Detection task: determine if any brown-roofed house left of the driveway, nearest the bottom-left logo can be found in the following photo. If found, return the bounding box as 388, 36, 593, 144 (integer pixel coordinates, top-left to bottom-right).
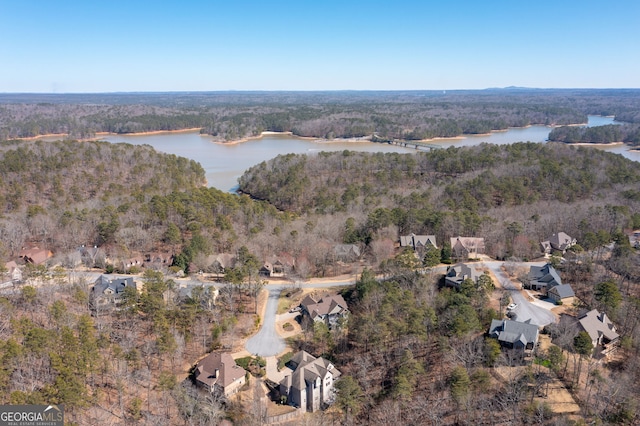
194, 352, 246, 397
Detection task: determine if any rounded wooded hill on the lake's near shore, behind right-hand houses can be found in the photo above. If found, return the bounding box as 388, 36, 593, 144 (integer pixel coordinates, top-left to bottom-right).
240, 143, 640, 258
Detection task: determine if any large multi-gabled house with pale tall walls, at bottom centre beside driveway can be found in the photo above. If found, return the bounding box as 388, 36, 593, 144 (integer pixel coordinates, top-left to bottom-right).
280, 351, 341, 412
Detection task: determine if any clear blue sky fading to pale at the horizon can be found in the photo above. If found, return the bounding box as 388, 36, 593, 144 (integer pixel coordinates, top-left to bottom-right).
0, 0, 640, 93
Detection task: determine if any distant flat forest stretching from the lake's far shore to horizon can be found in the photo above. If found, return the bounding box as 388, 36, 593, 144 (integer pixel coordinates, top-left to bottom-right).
0, 89, 640, 141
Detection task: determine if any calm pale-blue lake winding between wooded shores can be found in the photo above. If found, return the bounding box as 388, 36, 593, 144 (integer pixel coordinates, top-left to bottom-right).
96, 116, 640, 191
